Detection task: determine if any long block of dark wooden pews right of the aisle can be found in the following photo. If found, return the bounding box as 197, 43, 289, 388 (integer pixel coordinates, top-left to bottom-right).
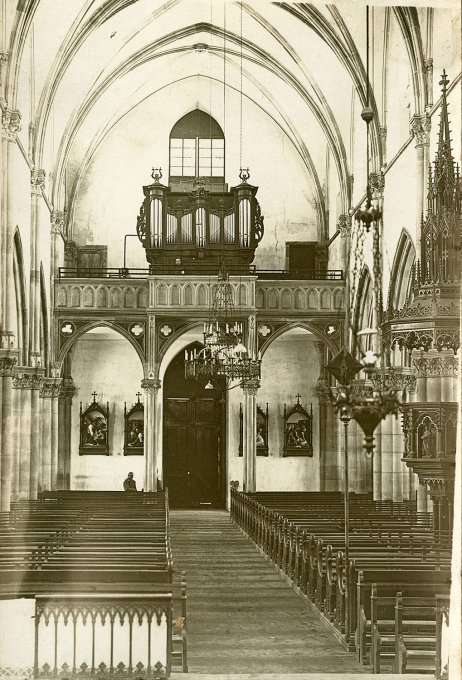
231, 489, 450, 667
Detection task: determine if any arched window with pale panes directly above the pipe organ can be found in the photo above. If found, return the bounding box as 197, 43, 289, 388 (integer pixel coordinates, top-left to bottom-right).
170, 109, 225, 182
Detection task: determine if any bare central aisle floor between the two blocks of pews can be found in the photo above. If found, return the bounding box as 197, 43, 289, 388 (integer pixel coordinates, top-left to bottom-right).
170, 510, 367, 673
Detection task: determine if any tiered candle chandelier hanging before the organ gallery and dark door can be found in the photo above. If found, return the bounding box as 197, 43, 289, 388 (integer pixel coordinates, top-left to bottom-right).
184, 262, 261, 389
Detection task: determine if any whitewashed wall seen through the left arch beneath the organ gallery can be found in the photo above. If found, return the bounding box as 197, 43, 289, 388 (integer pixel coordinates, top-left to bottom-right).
67, 326, 144, 491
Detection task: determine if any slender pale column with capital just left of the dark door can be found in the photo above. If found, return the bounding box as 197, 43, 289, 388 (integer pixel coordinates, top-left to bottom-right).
141, 378, 161, 491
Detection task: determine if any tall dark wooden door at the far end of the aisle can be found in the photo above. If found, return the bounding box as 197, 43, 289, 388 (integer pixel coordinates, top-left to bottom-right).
163, 345, 226, 508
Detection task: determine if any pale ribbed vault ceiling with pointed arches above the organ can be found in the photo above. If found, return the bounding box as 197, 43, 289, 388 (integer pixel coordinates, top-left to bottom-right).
7, 0, 460, 250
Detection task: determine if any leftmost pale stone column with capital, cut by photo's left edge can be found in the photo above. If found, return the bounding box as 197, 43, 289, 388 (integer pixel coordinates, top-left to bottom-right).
0, 351, 17, 512
